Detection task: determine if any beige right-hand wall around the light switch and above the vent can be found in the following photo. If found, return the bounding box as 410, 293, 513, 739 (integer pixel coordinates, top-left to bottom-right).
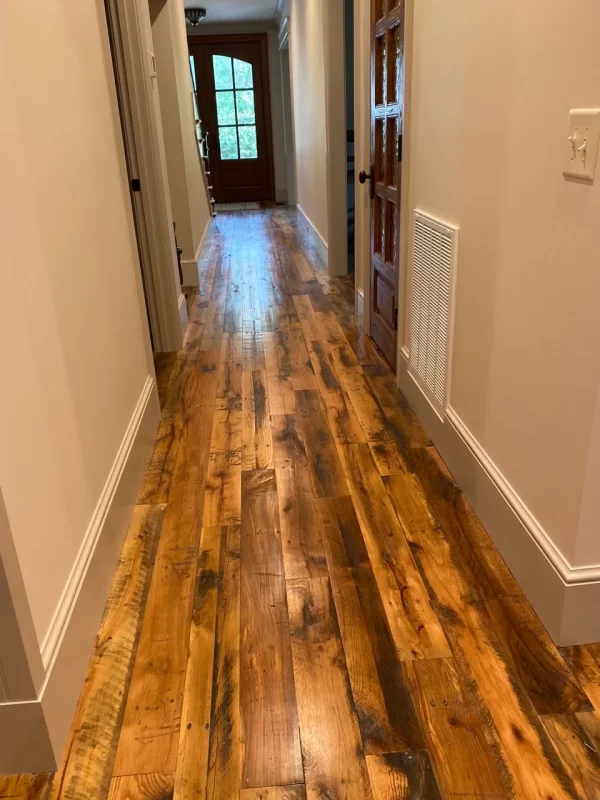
410, 0, 600, 565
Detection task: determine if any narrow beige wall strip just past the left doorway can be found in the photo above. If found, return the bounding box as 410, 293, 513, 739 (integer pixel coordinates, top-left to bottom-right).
149, 0, 210, 261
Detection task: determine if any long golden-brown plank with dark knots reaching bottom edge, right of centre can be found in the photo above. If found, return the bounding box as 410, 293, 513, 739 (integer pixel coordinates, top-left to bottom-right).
386, 475, 576, 800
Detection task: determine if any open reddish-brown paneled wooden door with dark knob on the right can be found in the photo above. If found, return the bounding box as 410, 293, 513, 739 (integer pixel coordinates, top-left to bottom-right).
360, 0, 404, 370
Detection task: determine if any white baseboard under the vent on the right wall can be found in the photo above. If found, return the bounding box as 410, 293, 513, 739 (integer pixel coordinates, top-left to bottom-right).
398, 352, 600, 645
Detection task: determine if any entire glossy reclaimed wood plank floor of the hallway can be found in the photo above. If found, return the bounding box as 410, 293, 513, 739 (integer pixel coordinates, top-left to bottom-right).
0, 209, 600, 800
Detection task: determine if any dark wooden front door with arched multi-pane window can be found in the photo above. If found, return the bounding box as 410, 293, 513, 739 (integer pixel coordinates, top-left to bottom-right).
188, 34, 275, 203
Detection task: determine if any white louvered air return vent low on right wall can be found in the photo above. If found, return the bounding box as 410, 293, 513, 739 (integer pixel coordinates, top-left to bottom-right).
408, 211, 458, 417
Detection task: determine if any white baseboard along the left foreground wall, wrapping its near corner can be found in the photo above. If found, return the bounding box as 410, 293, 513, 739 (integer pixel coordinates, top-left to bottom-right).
0, 376, 160, 774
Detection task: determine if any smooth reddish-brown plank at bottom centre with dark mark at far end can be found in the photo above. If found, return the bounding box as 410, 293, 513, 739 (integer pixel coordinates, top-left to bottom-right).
239, 470, 303, 788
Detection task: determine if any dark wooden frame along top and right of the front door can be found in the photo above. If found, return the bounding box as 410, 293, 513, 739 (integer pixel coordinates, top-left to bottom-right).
187, 22, 288, 203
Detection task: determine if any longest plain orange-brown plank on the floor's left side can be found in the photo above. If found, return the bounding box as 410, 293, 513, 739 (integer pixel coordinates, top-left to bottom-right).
114, 350, 220, 775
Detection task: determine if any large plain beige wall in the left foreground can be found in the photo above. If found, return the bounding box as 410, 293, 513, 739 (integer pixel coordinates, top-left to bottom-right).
0, 0, 152, 643
